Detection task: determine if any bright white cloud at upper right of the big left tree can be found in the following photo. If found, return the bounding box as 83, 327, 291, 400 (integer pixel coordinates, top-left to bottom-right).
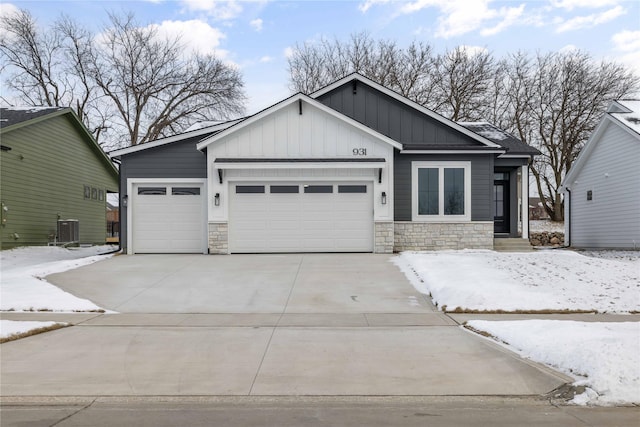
152, 19, 228, 58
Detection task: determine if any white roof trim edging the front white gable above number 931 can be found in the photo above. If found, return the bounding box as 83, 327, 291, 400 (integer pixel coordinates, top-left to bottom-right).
196, 93, 402, 150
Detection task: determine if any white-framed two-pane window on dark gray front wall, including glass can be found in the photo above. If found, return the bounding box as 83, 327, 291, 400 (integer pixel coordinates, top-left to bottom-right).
411, 162, 471, 222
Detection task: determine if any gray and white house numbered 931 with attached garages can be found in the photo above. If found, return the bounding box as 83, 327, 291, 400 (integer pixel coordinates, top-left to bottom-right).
111, 74, 538, 254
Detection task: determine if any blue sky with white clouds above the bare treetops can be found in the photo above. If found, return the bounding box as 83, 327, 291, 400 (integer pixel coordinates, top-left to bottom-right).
0, 0, 640, 113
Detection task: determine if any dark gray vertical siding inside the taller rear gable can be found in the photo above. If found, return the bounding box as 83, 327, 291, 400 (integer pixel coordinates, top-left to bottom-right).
317, 82, 481, 147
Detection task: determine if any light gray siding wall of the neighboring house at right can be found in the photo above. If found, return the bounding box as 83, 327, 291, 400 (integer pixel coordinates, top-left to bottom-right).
569, 123, 640, 249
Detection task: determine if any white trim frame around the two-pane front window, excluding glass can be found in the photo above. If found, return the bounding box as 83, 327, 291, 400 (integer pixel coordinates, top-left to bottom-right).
411, 161, 471, 222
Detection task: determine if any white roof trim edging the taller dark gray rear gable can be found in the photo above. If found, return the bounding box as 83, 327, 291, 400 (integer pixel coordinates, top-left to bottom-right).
310, 73, 503, 149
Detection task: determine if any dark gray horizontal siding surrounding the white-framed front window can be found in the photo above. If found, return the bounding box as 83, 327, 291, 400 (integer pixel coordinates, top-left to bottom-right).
394, 153, 493, 221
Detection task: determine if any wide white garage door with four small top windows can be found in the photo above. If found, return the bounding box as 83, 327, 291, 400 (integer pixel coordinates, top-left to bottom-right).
229, 182, 374, 253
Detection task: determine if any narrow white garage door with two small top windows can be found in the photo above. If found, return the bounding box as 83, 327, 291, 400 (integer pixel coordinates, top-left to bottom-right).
130, 183, 206, 253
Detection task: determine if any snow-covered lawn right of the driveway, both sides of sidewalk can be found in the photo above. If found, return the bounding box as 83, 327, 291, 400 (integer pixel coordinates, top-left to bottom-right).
394, 250, 640, 405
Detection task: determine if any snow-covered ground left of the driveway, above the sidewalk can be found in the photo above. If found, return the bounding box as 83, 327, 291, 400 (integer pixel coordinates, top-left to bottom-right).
0, 245, 117, 311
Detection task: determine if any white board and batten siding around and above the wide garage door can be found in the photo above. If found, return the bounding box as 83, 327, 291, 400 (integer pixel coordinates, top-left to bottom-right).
207, 101, 393, 221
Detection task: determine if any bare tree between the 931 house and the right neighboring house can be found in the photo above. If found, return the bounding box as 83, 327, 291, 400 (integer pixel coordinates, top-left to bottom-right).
505, 51, 639, 221
